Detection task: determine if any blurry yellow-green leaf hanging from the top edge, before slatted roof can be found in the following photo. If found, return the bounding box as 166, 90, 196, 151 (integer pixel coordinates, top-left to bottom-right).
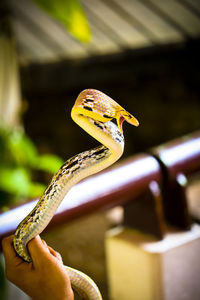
34, 0, 90, 42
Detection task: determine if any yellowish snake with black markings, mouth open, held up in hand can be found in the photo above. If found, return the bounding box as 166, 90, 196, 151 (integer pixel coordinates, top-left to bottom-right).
13, 89, 139, 300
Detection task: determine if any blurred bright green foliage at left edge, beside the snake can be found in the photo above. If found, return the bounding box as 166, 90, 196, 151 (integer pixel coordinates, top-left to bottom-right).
0, 127, 63, 207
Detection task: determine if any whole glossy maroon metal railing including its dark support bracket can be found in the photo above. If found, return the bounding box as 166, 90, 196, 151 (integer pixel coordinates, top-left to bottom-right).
0, 132, 200, 246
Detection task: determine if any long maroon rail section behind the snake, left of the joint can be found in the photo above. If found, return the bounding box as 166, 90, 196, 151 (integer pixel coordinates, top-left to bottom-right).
0, 154, 161, 244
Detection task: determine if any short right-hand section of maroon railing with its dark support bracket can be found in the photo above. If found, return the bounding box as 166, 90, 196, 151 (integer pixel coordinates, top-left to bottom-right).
152, 131, 200, 230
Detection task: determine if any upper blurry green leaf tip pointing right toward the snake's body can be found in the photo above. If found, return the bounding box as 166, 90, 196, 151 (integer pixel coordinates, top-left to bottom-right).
36, 154, 63, 173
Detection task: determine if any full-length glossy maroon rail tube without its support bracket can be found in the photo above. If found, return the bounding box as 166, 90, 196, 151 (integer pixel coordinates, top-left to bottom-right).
0, 131, 200, 246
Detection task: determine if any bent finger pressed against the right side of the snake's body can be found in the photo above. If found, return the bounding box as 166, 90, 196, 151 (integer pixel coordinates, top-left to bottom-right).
27, 235, 50, 266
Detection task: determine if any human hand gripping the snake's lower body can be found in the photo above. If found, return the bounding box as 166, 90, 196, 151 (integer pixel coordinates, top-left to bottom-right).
2, 236, 74, 300
